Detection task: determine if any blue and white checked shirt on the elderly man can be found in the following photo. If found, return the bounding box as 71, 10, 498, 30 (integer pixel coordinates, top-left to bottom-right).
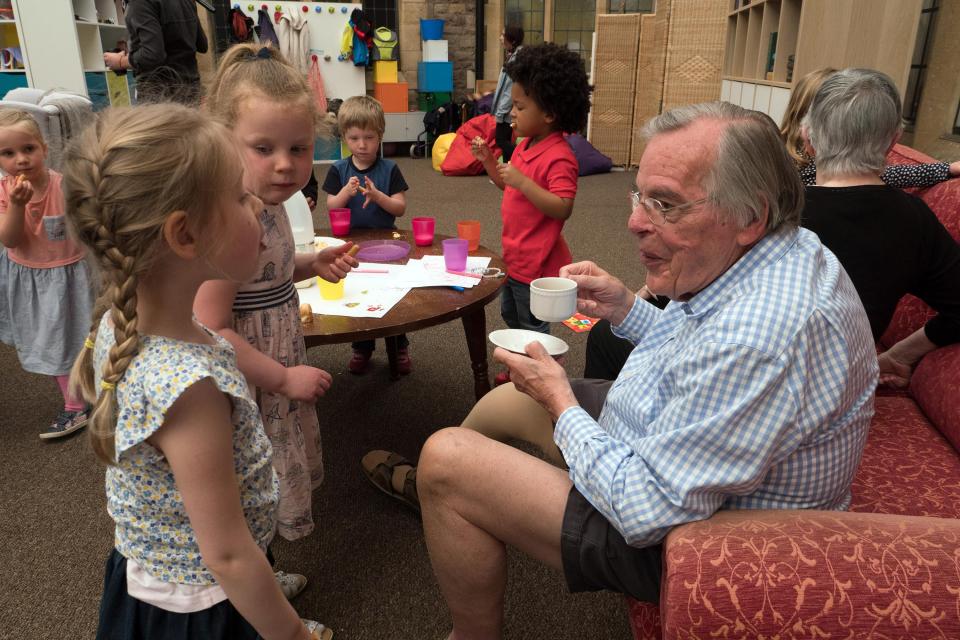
554, 229, 877, 547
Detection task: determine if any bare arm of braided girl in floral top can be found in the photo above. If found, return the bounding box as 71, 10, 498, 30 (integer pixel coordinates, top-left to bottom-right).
148, 380, 309, 640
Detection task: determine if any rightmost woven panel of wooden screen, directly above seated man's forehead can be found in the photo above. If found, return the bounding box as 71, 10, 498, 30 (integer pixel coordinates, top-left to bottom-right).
661, 0, 727, 111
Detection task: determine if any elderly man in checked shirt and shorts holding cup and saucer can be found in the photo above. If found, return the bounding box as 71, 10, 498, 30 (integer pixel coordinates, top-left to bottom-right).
417, 103, 877, 638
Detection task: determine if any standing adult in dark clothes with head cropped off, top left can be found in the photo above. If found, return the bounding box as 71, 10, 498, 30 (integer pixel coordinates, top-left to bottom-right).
103, 0, 207, 105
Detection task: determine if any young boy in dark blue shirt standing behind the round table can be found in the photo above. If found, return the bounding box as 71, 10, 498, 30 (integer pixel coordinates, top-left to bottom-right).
323, 96, 411, 375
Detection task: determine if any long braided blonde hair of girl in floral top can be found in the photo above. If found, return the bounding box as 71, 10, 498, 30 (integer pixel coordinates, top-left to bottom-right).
63, 104, 241, 464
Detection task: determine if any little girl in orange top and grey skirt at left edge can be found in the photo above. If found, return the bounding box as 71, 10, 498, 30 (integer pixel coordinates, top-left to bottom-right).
0, 109, 93, 439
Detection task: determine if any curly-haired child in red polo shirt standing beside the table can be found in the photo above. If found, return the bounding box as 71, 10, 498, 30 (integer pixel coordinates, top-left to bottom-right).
471, 43, 591, 344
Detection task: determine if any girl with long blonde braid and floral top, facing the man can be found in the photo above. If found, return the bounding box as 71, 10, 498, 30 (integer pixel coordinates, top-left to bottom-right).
64, 105, 332, 640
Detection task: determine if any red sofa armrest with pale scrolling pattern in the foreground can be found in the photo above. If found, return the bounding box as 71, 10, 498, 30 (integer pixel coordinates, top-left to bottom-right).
660, 511, 960, 639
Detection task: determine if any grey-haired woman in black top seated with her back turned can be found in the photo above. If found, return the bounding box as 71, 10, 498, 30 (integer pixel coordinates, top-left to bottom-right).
803, 69, 960, 385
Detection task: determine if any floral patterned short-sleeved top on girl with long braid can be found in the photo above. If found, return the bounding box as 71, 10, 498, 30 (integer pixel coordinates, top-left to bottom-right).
94, 315, 279, 585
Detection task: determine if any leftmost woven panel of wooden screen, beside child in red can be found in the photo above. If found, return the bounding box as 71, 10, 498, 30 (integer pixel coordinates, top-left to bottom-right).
589, 13, 641, 164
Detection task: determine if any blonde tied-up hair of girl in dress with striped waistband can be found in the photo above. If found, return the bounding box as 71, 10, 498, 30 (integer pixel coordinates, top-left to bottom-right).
206, 43, 333, 138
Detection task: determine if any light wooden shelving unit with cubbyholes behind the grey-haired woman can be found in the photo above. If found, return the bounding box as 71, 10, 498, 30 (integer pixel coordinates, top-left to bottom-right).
720, 0, 922, 122
